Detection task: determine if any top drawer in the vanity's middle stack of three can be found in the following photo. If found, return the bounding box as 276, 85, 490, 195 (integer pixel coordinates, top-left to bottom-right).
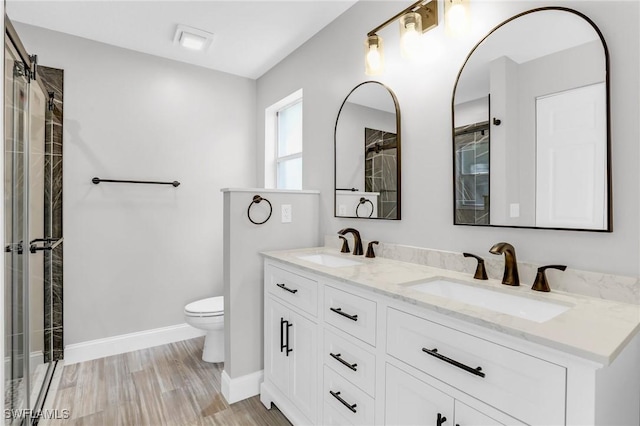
324, 286, 376, 346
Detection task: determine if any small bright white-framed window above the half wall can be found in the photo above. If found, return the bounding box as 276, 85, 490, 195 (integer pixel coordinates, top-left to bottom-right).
265, 90, 302, 189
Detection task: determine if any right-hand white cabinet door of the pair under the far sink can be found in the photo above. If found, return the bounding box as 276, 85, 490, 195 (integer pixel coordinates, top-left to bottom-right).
285, 312, 319, 423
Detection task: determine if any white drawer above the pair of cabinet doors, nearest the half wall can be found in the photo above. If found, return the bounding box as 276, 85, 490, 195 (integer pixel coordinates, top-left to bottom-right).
265, 265, 318, 316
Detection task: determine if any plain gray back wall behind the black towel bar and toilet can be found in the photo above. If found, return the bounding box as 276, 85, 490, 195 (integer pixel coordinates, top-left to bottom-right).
16, 24, 256, 344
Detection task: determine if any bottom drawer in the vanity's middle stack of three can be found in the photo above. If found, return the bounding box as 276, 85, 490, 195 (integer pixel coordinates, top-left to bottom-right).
323, 365, 375, 425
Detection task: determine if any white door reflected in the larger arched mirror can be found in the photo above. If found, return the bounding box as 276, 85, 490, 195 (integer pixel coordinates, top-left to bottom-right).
536, 83, 607, 229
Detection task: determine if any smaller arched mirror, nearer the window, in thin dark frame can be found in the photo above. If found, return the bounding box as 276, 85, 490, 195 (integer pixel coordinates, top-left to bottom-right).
334, 81, 400, 220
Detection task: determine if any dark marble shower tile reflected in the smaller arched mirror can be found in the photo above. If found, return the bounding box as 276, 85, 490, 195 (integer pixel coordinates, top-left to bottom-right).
364, 128, 398, 219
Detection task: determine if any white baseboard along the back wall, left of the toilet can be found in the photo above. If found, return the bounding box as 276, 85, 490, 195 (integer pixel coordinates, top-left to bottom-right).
64, 324, 206, 365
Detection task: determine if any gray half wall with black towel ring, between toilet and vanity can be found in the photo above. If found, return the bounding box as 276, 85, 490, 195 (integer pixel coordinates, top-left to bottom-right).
224, 189, 321, 379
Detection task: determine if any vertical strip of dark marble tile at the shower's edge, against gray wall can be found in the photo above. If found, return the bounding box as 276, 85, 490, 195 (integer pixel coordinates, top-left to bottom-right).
38, 67, 64, 362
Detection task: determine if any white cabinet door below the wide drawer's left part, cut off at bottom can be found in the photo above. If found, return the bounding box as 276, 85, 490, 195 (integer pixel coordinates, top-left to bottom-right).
385, 364, 462, 426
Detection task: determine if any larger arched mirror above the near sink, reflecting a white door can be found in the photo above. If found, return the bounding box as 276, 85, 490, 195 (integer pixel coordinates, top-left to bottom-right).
452, 7, 612, 232
